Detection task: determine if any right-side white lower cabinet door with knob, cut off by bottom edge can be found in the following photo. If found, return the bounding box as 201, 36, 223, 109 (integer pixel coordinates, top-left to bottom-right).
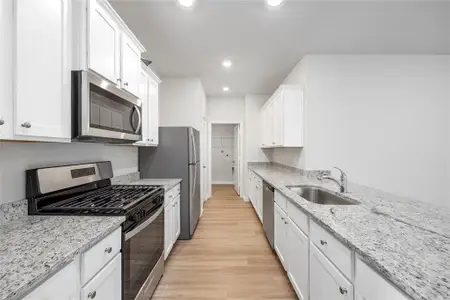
310, 243, 353, 300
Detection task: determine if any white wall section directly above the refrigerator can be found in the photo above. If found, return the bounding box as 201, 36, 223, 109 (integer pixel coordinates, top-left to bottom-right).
159, 78, 206, 131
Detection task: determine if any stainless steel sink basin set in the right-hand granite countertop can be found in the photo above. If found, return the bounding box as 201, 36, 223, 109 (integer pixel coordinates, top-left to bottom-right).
287, 186, 359, 205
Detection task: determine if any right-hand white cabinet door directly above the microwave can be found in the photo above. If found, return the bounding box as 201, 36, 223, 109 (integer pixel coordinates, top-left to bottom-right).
120, 34, 141, 95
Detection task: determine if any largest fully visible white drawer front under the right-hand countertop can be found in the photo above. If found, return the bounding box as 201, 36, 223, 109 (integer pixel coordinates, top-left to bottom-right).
310, 221, 352, 279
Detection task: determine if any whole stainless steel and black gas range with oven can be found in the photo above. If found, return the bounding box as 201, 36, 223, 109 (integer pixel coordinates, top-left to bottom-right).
26, 162, 164, 300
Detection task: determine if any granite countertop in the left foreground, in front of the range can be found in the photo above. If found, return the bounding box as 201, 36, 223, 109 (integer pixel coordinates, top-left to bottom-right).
0, 216, 125, 300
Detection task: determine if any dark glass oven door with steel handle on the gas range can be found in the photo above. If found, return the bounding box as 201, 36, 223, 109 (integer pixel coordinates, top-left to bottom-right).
123, 205, 164, 300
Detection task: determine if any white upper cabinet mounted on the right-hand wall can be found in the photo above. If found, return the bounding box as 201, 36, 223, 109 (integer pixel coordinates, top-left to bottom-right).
260, 85, 304, 148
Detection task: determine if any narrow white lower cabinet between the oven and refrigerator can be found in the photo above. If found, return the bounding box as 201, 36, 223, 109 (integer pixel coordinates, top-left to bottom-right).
164, 185, 181, 259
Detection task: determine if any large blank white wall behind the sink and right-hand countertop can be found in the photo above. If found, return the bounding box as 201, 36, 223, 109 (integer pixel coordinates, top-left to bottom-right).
272, 55, 450, 205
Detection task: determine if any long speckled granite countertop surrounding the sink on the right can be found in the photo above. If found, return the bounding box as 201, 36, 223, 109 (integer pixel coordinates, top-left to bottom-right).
249, 164, 450, 300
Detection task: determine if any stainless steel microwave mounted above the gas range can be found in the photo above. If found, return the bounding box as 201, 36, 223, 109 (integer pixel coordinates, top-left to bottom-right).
72, 71, 142, 143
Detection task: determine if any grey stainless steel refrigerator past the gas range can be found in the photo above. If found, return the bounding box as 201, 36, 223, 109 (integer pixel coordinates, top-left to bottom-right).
139, 127, 201, 240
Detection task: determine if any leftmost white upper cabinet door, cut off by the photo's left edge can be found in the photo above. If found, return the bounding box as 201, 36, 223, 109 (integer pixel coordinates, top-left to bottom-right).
0, 0, 13, 139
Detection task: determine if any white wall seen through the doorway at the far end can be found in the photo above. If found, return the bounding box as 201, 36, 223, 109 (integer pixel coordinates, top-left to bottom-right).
211, 124, 237, 184
